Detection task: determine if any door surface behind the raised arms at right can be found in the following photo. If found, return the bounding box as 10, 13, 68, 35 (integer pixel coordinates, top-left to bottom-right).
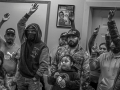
91, 10, 120, 45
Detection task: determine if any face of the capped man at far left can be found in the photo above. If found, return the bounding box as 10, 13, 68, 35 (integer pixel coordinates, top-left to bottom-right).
4, 33, 16, 45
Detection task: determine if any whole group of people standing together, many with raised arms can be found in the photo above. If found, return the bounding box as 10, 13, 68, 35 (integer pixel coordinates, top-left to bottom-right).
0, 3, 120, 90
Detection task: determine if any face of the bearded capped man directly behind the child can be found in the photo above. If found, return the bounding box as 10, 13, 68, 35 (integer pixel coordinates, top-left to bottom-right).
68, 35, 79, 48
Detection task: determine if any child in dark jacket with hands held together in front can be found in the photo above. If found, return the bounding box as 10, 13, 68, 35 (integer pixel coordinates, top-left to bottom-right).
48, 55, 80, 90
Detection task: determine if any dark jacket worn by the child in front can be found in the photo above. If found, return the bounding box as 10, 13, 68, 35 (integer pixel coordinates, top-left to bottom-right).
48, 69, 80, 90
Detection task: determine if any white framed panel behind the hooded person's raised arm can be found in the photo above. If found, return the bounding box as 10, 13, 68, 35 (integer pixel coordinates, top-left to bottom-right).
0, 2, 47, 45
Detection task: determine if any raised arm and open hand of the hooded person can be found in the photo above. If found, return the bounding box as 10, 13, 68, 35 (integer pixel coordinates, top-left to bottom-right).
17, 3, 39, 44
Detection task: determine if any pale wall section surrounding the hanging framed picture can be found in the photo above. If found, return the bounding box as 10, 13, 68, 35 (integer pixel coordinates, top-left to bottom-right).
26, 0, 85, 51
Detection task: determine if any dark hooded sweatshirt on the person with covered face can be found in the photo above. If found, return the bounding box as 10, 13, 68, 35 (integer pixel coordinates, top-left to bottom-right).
18, 14, 48, 78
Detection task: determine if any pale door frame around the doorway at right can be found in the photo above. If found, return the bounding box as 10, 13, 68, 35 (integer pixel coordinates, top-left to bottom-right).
81, 0, 120, 48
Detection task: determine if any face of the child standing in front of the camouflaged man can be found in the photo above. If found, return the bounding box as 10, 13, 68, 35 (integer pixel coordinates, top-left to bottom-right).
60, 57, 72, 70
